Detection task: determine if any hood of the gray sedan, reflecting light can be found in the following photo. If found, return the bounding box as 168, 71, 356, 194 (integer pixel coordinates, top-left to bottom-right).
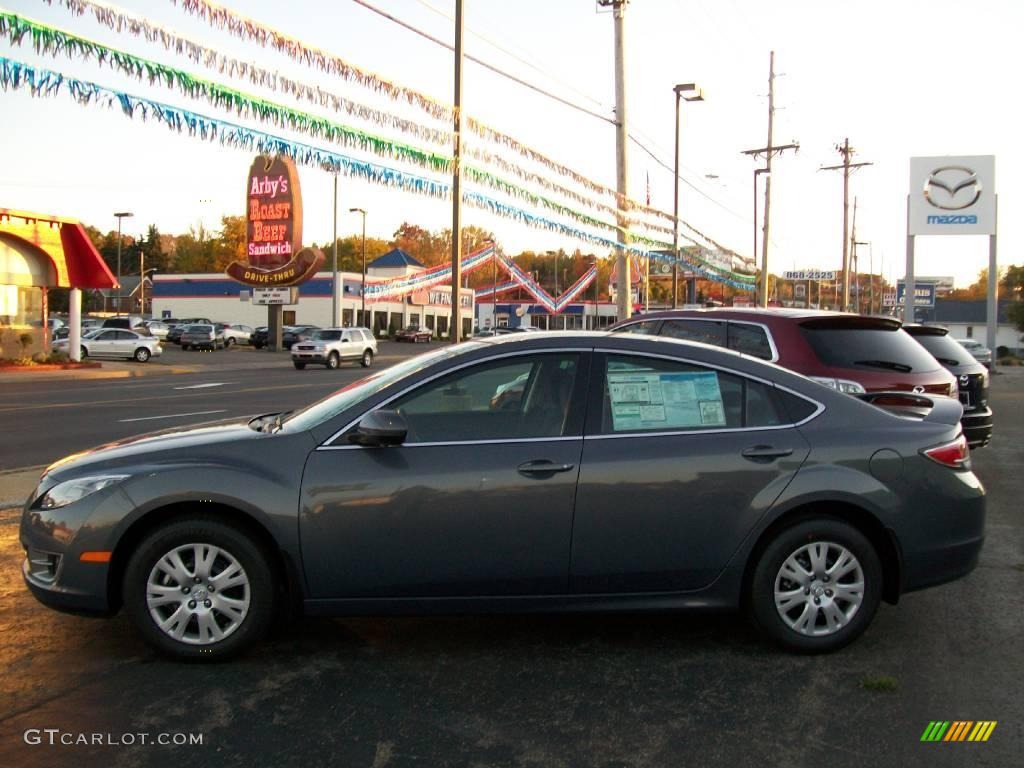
43, 418, 272, 480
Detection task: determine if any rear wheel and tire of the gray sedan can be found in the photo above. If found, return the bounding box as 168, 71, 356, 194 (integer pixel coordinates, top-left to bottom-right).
748, 517, 883, 653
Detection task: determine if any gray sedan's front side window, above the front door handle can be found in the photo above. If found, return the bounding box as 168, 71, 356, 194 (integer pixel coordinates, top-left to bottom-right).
389, 353, 580, 443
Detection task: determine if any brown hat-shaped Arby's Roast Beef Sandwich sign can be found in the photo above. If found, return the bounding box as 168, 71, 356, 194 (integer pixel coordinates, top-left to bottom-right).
225, 155, 324, 288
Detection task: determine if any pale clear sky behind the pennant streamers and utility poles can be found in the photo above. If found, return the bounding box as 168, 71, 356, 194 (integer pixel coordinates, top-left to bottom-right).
0, 0, 1024, 287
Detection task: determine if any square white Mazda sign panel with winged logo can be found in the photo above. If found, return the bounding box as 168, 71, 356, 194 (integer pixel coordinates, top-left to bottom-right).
907, 155, 995, 234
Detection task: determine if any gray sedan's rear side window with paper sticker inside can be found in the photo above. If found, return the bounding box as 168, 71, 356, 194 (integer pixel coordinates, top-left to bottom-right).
601, 355, 791, 434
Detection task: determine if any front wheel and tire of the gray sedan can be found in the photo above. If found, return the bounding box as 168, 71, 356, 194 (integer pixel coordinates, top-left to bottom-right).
122, 515, 275, 662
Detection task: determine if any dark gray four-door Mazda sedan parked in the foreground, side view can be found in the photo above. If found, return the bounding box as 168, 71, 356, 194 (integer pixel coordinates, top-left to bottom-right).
20, 333, 985, 659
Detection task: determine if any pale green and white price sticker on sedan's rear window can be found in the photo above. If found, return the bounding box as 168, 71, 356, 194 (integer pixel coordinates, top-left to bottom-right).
608, 371, 725, 432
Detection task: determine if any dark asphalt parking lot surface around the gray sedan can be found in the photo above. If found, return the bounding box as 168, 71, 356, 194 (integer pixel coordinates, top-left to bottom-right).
0, 364, 1024, 768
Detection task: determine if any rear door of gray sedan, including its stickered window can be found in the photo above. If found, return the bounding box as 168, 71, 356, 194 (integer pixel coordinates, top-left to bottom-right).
570, 353, 809, 594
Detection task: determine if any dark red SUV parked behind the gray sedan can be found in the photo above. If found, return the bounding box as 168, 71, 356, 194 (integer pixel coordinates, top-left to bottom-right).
609, 308, 957, 397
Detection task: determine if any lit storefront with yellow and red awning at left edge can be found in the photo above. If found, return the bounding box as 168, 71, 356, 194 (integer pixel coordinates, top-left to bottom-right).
0, 208, 117, 356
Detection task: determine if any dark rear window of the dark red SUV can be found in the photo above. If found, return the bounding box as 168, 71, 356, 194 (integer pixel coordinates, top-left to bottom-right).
800, 324, 939, 374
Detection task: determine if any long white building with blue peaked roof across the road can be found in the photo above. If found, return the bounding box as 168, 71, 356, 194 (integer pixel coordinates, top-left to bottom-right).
153, 249, 473, 338
